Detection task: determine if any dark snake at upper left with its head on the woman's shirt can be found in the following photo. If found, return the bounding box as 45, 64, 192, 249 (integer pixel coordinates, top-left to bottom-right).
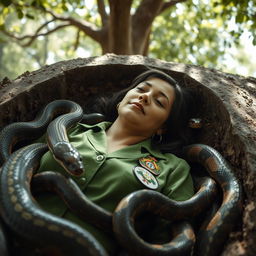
0, 100, 84, 176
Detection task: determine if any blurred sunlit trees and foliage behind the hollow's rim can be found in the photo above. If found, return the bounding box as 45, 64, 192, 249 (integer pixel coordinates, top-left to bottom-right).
0, 0, 256, 79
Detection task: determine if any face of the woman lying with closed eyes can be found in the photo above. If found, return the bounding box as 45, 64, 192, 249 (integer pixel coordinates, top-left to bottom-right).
118, 77, 175, 136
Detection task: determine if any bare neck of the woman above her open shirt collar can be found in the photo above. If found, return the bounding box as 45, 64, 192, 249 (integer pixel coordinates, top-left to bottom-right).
106, 119, 147, 153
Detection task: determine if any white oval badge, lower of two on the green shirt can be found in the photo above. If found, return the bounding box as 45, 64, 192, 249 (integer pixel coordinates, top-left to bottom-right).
133, 166, 158, 189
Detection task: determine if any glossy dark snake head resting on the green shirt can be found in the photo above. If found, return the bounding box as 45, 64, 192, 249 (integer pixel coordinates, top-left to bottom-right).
52, 141, 84, 176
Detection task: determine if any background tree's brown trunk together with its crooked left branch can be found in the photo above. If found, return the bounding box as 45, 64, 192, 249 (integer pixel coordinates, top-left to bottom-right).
1, 0, 183, 55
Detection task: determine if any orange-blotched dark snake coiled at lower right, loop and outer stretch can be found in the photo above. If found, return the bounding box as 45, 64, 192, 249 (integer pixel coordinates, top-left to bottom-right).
113, 144, 242, 256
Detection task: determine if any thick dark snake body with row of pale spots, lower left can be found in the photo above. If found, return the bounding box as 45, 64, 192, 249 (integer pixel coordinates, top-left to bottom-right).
0, 144, 107, 256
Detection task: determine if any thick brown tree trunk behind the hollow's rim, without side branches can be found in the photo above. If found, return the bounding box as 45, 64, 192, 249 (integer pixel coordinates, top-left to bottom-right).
99, 0, 164, 55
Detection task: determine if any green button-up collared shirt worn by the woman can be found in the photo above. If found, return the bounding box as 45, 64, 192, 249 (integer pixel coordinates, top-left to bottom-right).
35, 122, 194, 254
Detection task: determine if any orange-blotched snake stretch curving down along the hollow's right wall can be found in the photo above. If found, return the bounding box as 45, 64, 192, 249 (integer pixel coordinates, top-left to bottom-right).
184, 144, 242, 256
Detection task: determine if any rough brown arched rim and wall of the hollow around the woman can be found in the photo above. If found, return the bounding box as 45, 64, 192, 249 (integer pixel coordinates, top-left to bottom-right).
0, 54, 256, 256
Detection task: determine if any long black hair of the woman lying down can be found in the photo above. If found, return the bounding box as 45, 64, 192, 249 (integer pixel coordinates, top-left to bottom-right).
91, 69, 197, 155
